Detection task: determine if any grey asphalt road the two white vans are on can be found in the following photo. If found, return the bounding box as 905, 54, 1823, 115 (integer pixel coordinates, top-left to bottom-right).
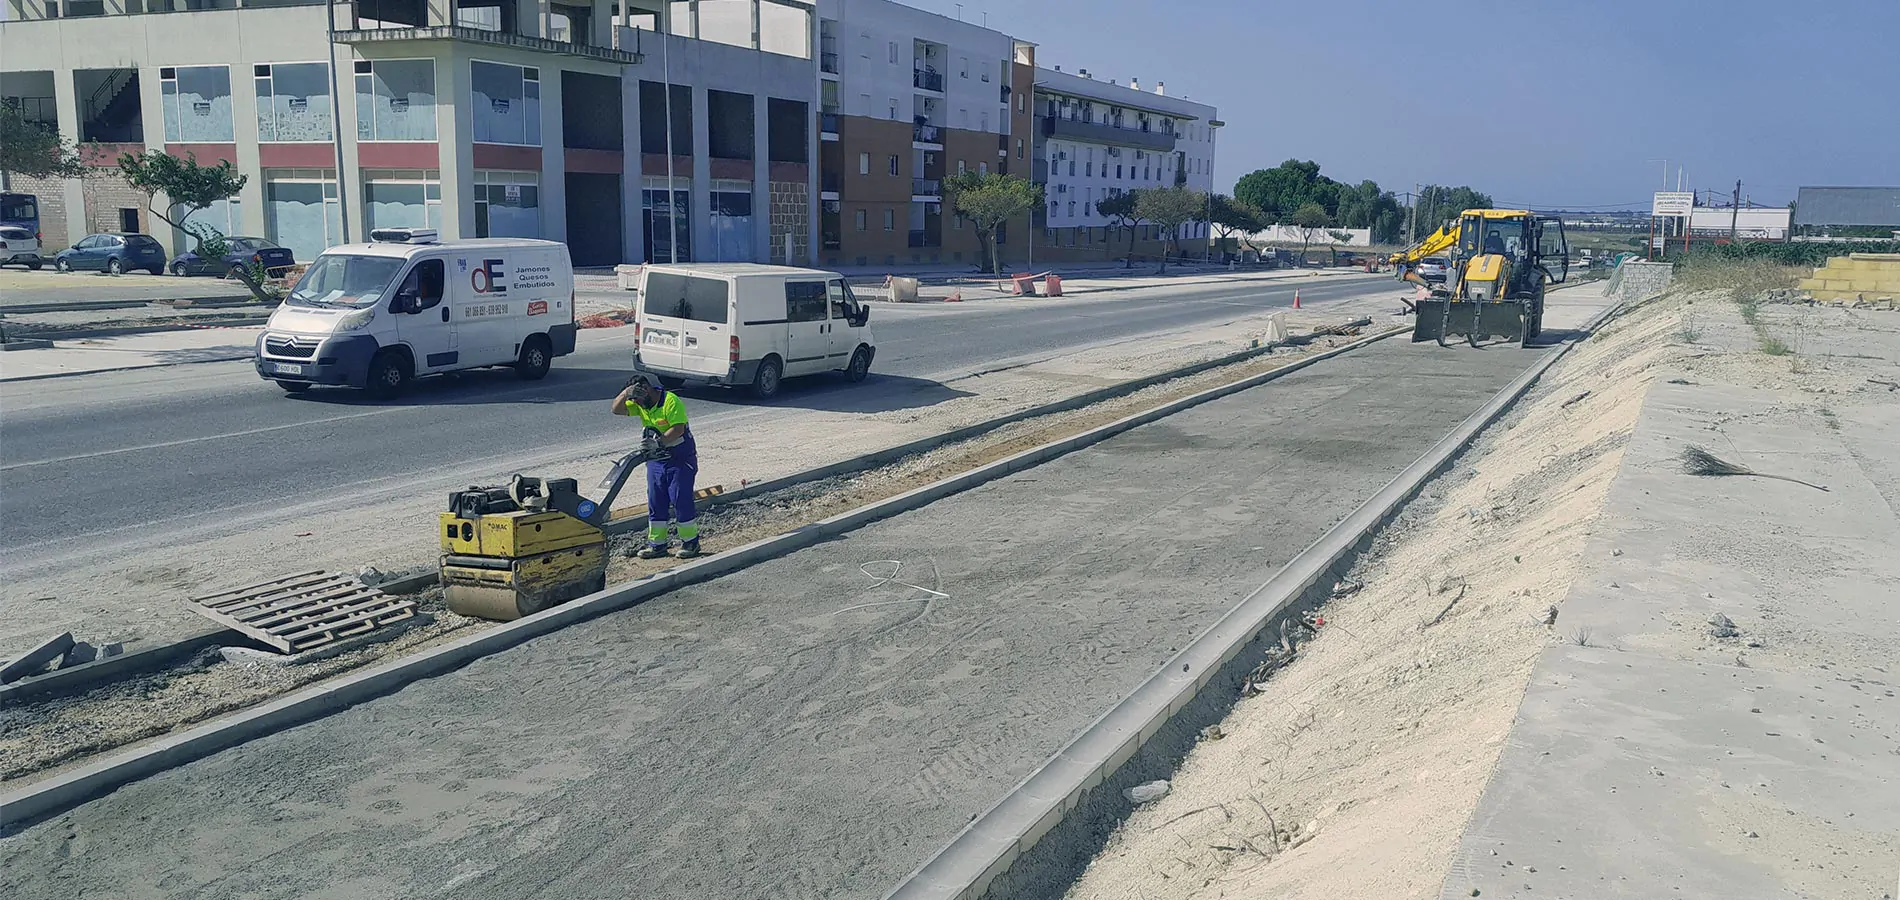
0, 275, 1391, 575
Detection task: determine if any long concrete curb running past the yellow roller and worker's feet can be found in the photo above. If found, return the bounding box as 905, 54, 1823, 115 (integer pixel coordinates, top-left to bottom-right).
0, 328, 1400, 834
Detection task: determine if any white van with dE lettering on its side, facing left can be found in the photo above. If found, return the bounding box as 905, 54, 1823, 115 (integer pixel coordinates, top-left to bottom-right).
255, 228, 576, 397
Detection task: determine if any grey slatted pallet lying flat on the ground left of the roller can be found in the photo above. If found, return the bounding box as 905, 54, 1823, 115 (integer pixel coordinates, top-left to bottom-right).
190, 572, 416, 653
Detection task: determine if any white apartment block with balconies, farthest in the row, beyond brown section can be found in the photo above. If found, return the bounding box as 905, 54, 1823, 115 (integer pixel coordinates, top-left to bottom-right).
1032, 66, 1222, 262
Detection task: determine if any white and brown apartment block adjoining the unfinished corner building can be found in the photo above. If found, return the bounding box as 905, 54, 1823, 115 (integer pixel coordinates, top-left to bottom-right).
817, 0, 1026, 266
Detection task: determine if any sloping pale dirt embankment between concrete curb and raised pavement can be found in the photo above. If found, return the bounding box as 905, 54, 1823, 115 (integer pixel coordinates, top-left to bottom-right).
1068, 290, 1689, 900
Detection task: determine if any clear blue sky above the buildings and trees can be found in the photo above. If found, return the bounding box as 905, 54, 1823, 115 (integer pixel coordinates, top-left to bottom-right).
903, 0, 1900, 207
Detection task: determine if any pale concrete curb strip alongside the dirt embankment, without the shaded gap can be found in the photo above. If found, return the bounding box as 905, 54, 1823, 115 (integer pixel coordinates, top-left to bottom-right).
884, 306, 1617, 900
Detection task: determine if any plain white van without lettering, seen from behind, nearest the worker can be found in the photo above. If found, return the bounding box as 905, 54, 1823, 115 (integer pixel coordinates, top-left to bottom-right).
633, 262, 878, 397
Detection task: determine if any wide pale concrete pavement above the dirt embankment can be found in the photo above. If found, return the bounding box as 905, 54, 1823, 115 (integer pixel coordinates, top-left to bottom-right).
1442, 304, 1900, 900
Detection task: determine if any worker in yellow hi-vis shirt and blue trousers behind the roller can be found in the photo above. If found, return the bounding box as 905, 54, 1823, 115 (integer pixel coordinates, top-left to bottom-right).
614, 372, 699, 560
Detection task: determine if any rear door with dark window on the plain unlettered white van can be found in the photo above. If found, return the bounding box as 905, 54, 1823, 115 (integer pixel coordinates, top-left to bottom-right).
640, 270, 733, 376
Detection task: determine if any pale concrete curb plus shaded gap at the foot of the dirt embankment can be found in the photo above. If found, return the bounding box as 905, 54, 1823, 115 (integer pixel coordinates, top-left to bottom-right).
884, 306, 1621, 900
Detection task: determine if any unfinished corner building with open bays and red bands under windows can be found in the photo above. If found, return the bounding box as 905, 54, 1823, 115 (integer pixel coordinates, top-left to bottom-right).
0, 0, 817, 264
